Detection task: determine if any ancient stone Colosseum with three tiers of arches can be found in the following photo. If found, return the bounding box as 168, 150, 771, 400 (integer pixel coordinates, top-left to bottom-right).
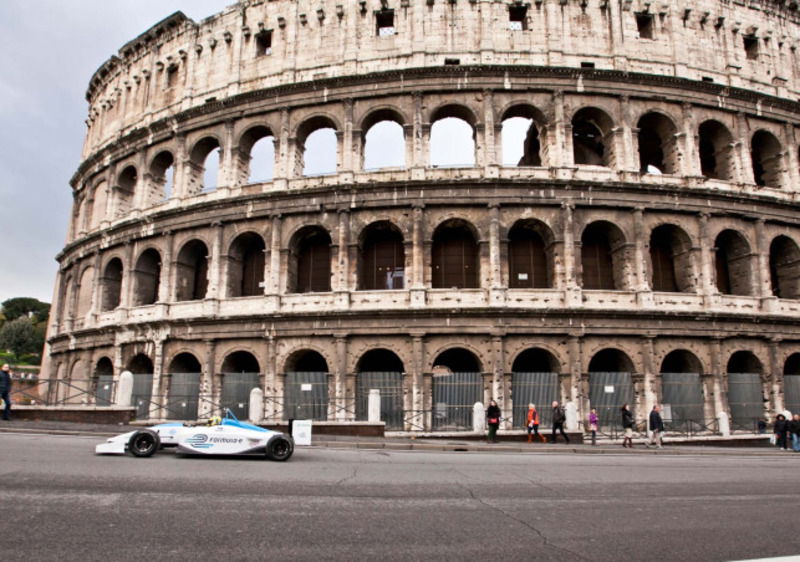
44, 0, 800, 432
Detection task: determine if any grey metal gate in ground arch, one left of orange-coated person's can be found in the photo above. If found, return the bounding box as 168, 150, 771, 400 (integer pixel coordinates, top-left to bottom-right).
431, 373, 483, 431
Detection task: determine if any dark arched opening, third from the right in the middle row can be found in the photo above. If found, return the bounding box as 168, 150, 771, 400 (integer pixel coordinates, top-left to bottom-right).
650, 224, 695, 293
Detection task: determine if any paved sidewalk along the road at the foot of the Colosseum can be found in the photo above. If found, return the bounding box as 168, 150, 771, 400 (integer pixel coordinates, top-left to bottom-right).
0, 420, 800, 459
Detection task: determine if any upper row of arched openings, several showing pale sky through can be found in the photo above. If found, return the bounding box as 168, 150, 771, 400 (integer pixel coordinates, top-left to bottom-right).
76, 104, 787, 234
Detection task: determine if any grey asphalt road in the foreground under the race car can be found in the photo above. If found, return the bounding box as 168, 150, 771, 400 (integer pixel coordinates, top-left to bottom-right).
0, 434, 800, 562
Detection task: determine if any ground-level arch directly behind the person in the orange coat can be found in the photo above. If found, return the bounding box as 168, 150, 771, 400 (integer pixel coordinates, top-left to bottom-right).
511, 348, 561, 428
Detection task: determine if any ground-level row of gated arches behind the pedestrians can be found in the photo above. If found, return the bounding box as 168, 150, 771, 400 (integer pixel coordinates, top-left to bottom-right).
72, 347, 800, 430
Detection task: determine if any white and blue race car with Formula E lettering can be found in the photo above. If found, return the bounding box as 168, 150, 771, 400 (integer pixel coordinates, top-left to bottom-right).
94, 411, 294, 461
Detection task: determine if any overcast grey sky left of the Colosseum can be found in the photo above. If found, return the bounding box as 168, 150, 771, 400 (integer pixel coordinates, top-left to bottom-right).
0, 0, 235, 302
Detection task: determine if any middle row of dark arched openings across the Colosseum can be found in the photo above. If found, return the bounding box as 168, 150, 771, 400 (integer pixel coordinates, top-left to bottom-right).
77, 219, 800, 315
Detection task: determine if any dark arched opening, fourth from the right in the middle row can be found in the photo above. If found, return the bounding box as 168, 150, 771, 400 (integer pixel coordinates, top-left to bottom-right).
581, 221, 628, 291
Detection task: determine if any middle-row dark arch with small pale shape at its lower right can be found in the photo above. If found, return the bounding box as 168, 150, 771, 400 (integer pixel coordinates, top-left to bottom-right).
358, 221, 406, 291
